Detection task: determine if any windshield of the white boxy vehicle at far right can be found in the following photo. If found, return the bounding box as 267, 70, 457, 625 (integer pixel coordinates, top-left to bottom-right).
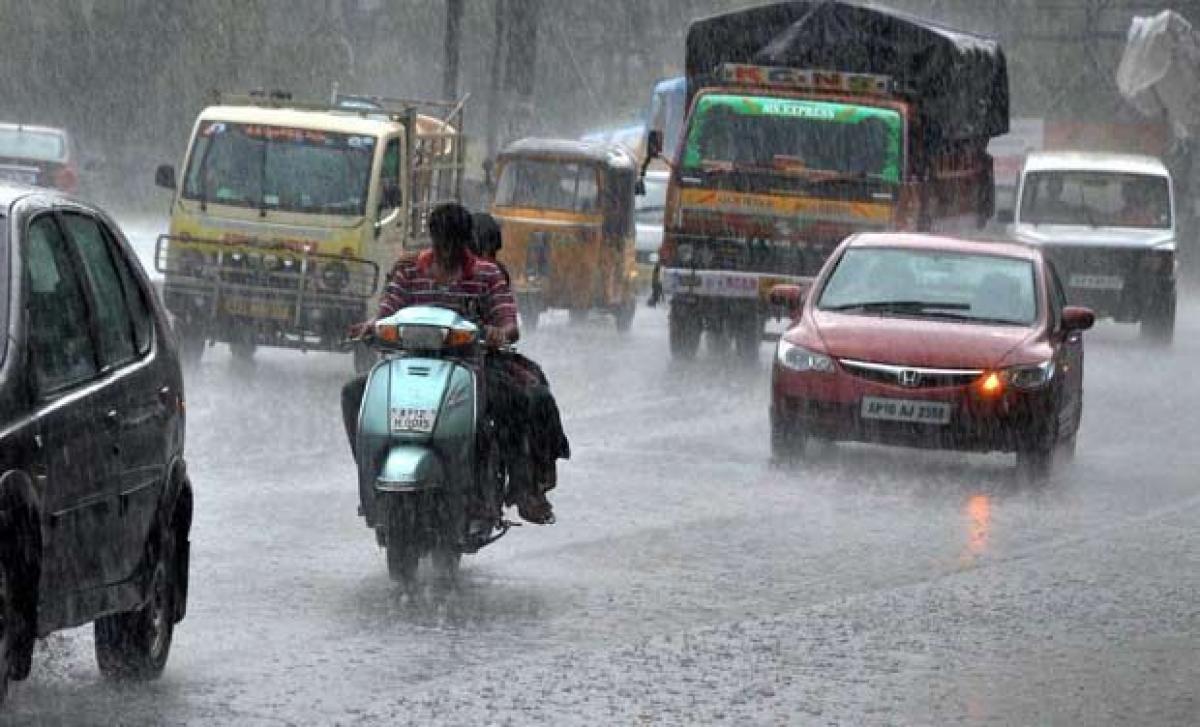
1021, 172, 1171, 229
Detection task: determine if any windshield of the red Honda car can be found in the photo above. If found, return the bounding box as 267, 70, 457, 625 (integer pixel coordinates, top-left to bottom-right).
817, 247, 1038, 325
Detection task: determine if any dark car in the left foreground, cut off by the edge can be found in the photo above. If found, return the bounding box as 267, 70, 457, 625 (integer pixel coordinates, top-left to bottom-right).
0, 184, 192, 696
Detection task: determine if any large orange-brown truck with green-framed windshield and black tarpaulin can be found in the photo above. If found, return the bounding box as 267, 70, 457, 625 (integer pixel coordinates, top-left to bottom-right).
647, 0, 1008, 358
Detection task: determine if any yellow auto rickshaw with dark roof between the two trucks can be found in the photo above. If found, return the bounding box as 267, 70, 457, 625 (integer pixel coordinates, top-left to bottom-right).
492, 139, 637, 331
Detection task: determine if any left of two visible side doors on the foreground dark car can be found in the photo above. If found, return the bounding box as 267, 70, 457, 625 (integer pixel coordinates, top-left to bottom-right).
23, 212, 116, 599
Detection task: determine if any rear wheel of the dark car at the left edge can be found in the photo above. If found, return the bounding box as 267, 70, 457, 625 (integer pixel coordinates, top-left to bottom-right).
96, 528, 178, 681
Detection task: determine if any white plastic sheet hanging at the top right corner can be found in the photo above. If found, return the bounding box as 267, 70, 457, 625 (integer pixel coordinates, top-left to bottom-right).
1117, 10, 1200, 137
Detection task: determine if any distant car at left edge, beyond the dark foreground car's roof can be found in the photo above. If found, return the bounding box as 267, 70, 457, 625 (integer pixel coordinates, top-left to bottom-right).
0, 124, 79, 194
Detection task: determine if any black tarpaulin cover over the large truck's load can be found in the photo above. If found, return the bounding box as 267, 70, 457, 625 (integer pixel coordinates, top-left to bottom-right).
686, 0, 1008, 148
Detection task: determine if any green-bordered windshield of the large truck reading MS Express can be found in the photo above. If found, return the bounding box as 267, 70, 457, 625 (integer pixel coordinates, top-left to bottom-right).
683, 94, 904, 182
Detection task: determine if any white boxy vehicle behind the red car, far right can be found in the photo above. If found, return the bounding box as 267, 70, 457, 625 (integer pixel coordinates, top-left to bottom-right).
1012, 151, 1176, 343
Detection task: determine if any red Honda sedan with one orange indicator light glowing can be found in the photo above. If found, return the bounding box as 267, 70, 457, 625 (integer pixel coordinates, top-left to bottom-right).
770, 233, 1094, 476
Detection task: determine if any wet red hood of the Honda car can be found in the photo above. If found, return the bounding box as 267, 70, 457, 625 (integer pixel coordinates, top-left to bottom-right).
811, 311, 1034, 368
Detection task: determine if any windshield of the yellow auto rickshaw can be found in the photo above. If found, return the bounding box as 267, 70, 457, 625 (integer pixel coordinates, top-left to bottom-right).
496, 160, 599, 212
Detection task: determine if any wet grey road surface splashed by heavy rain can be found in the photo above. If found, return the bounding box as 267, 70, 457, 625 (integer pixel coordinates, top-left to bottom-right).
4, 227, 1200, 725
